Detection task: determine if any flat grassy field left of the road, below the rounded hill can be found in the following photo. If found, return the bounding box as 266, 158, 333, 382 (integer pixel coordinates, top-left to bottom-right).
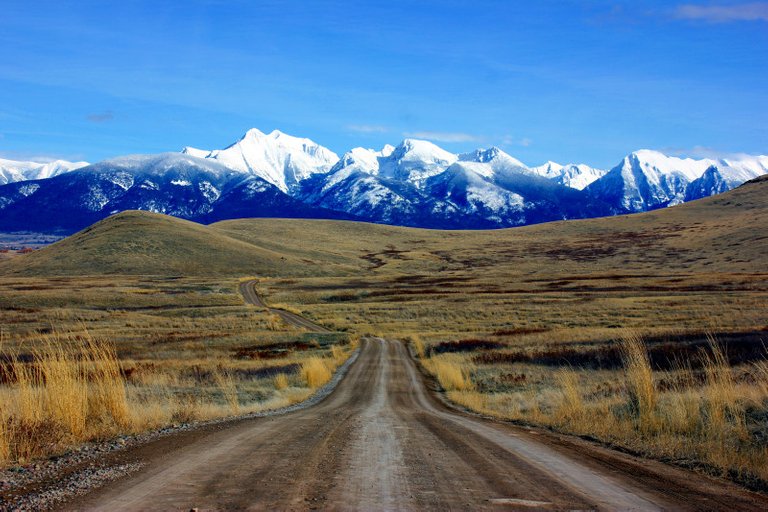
0, 277, 353, 463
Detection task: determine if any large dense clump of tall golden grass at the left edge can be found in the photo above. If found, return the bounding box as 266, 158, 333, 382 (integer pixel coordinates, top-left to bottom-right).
0, 334, 130, 462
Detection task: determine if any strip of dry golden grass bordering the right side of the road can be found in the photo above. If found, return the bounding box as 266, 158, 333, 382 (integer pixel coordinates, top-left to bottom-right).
412, 333, 768, 489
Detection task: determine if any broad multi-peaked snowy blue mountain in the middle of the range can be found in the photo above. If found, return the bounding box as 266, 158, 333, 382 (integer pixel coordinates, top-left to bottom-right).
297, 139, 608, 228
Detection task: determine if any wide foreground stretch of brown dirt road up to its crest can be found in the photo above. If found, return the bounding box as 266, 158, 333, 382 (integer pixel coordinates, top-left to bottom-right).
66, 339, 768, 510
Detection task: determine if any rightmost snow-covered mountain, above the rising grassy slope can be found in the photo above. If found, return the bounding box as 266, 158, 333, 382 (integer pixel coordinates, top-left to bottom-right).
586, 150, 768, 212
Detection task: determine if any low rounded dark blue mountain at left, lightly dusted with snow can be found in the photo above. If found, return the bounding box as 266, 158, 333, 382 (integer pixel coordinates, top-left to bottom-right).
0, 153, 350, 232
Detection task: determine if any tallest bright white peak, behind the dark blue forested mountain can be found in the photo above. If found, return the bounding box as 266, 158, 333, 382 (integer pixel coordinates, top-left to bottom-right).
182, 128, 339, 192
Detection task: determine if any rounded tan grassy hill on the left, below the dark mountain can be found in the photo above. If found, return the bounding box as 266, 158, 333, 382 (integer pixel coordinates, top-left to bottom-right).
0, 211, 354, 276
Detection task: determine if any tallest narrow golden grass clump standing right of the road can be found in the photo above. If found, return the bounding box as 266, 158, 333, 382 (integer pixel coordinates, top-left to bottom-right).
621, 334, 658, 431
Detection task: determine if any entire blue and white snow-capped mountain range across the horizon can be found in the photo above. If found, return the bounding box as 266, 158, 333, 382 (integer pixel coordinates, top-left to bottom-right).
0, 129, 768, 233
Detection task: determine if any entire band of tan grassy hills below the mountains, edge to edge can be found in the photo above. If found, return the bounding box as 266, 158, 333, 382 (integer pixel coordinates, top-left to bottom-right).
0, 180, 768, 277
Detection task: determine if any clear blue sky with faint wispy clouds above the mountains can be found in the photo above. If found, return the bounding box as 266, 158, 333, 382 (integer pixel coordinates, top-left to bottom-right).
0, 0, 768, 167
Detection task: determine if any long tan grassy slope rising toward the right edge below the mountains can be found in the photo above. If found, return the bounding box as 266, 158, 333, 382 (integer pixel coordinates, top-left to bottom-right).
211, 175, 768, 275
